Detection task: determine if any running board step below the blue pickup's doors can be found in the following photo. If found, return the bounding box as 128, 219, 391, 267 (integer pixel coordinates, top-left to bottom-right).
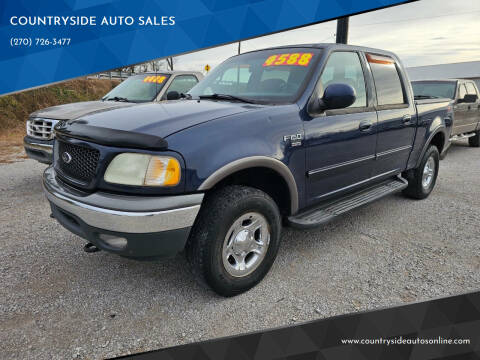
288, 175, 408, 229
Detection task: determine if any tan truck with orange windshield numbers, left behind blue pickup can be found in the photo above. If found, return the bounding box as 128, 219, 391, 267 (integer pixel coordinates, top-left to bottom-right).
23, 71, 203, 164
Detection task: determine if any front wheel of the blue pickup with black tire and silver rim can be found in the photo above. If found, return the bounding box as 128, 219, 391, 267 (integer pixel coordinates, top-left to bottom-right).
185, 185, 281, 297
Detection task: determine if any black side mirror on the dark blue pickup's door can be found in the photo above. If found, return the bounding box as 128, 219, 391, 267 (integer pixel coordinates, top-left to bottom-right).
308, 83, 357, 113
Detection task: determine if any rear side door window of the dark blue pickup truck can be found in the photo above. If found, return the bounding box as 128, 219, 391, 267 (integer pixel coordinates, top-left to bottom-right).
367, 54, 406, 105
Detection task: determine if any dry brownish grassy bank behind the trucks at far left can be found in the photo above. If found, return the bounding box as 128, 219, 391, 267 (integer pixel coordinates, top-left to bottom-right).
0, 79, 118, 163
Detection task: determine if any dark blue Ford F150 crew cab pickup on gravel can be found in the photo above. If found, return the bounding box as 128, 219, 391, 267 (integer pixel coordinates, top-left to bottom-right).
43, 44, 452, 296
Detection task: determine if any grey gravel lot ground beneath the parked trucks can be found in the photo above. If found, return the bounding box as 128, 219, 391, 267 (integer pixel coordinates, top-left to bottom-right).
0, 143, 480, 359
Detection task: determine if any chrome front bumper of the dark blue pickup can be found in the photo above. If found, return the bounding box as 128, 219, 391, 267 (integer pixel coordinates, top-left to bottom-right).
43, 167, 203, 234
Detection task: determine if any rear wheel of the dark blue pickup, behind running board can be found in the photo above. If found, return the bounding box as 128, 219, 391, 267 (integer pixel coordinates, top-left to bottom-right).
403, 145, 440, 200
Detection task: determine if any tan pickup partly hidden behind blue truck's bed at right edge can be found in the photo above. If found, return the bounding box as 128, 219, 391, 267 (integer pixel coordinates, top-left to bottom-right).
412, 79, 480, 148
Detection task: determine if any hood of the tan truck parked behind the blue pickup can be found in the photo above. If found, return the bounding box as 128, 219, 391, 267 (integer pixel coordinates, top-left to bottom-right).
30, 101, 137, 120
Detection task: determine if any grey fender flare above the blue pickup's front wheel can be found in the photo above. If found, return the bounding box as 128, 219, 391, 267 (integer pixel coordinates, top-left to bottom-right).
198, 156, 298, 214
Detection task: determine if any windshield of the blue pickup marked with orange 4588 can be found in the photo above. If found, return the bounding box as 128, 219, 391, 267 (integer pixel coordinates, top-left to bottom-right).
189, 48, 320, 103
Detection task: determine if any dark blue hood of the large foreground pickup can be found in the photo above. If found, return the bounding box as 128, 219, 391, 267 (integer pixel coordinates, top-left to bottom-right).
56, 100, 264, 143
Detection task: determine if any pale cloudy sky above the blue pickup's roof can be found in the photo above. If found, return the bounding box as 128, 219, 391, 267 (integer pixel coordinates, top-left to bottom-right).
174, 0, 480, 70
